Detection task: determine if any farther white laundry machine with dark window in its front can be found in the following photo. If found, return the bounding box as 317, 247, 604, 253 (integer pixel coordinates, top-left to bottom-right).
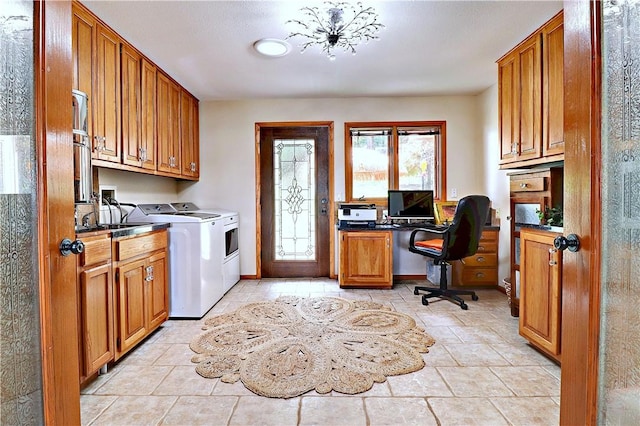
171, 202, 240, 293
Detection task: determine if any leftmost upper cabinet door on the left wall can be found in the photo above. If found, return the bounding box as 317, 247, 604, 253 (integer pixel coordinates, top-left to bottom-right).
71, 2, 96, 138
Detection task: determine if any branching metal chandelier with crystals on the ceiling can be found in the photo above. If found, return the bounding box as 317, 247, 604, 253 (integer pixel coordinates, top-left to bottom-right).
286, 1, 384, 60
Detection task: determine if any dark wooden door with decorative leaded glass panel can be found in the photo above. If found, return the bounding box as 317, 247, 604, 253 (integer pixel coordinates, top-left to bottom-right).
259, 126, 330, 277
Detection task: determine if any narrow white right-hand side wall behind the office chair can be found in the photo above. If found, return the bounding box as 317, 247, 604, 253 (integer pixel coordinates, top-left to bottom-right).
478, 84, 511, 285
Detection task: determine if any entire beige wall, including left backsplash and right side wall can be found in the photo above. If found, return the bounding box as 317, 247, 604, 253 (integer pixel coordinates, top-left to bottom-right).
100, 94, 509, 278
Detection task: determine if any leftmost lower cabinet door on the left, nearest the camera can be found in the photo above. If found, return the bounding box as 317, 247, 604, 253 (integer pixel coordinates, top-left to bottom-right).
79, 262, 115, 376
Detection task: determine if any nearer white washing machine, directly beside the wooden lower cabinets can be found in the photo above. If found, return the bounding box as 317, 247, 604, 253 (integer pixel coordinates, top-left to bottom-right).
127, 204, 226, 318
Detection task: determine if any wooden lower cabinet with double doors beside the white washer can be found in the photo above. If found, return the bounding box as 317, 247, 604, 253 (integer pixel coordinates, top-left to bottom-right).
113, 231, 169, 360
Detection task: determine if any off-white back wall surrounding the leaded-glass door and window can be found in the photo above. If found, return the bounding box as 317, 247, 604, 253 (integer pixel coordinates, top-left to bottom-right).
178, 96, 488, 275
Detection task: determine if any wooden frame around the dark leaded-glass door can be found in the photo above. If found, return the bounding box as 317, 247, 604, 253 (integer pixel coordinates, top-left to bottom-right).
255, 121, 337, 279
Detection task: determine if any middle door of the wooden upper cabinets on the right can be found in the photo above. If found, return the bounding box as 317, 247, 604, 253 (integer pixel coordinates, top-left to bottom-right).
517, 34, 542, 160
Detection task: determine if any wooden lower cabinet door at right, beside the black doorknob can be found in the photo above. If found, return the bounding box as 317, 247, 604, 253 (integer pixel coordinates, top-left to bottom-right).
520, 228, 562, 362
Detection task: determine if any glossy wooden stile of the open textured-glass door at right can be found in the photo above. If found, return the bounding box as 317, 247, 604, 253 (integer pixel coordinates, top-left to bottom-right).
560, 0, 602, 425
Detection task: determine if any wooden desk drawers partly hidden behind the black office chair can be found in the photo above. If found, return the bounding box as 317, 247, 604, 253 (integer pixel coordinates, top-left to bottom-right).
451, 229, 499, 287
